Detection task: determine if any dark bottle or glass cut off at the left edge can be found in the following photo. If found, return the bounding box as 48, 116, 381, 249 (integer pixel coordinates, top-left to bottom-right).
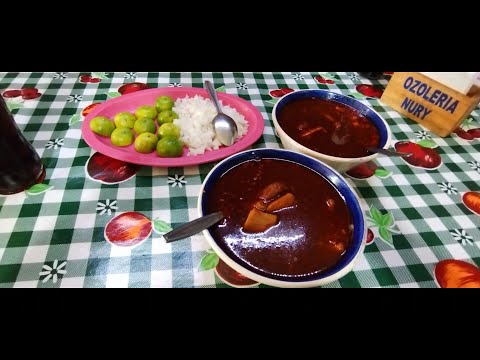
0, 95, 43, 195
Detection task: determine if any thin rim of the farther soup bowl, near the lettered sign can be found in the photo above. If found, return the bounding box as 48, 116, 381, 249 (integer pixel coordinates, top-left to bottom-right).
272, 89, 392, 163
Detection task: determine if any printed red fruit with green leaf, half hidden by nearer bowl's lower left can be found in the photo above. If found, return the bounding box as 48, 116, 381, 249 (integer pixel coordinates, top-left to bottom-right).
199, 250, 258, 287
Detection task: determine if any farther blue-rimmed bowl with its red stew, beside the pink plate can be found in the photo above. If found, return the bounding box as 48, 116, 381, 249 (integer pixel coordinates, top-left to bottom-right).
272, 90, 392, 173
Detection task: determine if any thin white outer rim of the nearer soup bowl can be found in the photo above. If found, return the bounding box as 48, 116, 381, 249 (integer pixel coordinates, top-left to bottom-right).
197, 148, 368, 288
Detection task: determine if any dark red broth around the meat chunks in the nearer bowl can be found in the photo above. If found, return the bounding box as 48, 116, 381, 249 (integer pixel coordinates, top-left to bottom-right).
206, 159, 353, 277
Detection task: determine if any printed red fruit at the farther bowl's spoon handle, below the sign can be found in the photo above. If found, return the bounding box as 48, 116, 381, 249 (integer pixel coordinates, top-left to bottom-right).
394, 140, 442, 170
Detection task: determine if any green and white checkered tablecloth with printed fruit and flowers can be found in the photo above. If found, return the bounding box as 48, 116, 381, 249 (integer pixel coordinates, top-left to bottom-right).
0, 72, 480, 287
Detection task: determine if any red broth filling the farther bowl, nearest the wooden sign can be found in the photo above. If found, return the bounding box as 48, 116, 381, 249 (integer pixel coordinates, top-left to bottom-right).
278, 98, 380, 158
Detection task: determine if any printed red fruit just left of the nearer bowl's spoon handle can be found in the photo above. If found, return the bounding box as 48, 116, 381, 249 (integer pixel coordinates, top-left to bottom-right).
104, 211, 152, 246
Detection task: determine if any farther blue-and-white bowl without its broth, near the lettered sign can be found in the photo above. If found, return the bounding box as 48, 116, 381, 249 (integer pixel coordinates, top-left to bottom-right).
272, 90, 392, 173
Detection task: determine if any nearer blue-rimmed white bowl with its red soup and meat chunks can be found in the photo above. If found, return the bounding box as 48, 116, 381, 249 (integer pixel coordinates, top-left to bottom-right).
198, 149, 367, 287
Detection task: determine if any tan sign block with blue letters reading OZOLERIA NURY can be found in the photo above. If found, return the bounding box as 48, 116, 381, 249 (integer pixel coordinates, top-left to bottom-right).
381, 72, 480, 137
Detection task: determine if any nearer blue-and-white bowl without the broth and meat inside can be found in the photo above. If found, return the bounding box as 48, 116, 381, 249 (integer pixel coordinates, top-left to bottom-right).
198, 149, 367, 287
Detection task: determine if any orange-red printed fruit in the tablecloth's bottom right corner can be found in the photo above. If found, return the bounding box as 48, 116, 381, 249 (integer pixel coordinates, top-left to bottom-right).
435, 260, 480, 288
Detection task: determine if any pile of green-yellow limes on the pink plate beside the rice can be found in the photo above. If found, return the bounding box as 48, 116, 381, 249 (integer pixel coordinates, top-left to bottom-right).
90, 95, 183, 157
